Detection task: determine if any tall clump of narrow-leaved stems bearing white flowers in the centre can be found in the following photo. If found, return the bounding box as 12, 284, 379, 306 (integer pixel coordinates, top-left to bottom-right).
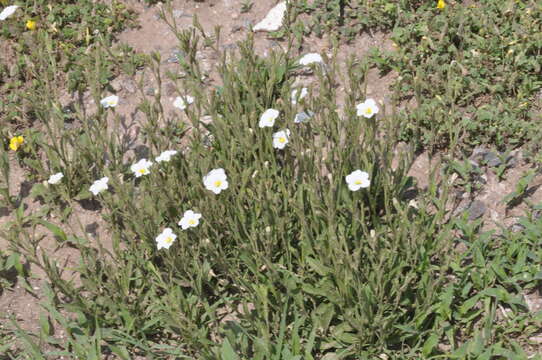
4, 26, 460, 359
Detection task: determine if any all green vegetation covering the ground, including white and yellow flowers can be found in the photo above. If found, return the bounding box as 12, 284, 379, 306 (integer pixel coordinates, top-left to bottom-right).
0, 0, 542, 360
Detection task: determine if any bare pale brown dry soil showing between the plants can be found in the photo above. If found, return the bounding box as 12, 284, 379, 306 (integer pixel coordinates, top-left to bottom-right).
0, 0, 542, 359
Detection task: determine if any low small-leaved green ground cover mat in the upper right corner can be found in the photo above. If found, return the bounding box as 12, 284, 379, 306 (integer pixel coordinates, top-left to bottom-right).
296, 0, 542, 153
